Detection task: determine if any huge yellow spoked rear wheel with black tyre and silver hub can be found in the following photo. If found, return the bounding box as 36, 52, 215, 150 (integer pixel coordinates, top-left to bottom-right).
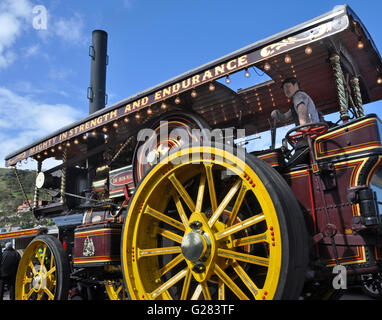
121, 144, 308, 300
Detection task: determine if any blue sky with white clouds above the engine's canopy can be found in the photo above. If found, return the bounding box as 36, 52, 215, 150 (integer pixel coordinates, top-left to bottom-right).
0, 0, 382, 170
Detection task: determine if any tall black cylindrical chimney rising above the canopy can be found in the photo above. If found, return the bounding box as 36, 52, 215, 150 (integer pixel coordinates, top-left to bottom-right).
88, 30, 108, 114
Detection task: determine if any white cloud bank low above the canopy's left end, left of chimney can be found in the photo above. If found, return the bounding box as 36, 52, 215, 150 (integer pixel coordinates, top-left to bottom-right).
0, 87, 83, 166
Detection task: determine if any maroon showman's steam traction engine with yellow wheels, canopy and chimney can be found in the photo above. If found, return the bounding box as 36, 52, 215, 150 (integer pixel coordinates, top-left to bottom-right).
6, 6, 382, 300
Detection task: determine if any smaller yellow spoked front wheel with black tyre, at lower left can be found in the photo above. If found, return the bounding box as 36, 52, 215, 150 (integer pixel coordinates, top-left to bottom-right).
16, 235, 69, 300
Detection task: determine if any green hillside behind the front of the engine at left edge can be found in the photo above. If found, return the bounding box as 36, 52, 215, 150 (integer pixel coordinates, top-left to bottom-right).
0, 168, 50, 229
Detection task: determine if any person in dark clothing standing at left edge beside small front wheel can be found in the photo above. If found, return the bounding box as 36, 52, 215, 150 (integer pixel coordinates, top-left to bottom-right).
0, 242, 21, 300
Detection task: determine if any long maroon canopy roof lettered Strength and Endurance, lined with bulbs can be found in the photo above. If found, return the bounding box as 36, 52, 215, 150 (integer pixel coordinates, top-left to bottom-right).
6, 5, 382, 165
